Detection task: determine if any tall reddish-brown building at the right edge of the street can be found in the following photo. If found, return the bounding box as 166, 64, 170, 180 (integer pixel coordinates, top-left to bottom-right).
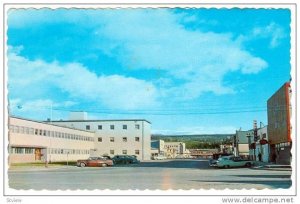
267, 82, 292, 164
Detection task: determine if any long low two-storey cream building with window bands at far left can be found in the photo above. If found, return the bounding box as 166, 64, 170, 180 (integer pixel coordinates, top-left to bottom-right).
8, 116, 95, 163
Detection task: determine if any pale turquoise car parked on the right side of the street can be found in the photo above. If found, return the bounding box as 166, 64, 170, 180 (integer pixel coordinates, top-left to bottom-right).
217, 156, 253, 168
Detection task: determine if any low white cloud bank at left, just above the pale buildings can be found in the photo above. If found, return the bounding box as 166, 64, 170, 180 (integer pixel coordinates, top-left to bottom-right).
8, 48, 158, 109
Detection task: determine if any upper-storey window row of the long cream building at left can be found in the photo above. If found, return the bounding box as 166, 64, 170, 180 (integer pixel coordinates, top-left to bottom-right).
9, 125, 94, 141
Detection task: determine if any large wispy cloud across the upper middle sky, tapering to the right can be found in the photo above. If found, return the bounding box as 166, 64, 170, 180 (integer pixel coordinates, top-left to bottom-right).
92, 10, 268, 99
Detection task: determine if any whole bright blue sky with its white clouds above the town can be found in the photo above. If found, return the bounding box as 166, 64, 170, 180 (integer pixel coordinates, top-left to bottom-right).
7, 9, 290, 134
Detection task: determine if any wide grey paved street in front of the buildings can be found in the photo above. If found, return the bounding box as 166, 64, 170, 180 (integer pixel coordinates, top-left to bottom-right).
8, 159, 291, 190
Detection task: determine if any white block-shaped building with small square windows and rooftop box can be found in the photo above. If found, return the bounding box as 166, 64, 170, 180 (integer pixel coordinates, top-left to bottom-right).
51, 112, 151, 160
